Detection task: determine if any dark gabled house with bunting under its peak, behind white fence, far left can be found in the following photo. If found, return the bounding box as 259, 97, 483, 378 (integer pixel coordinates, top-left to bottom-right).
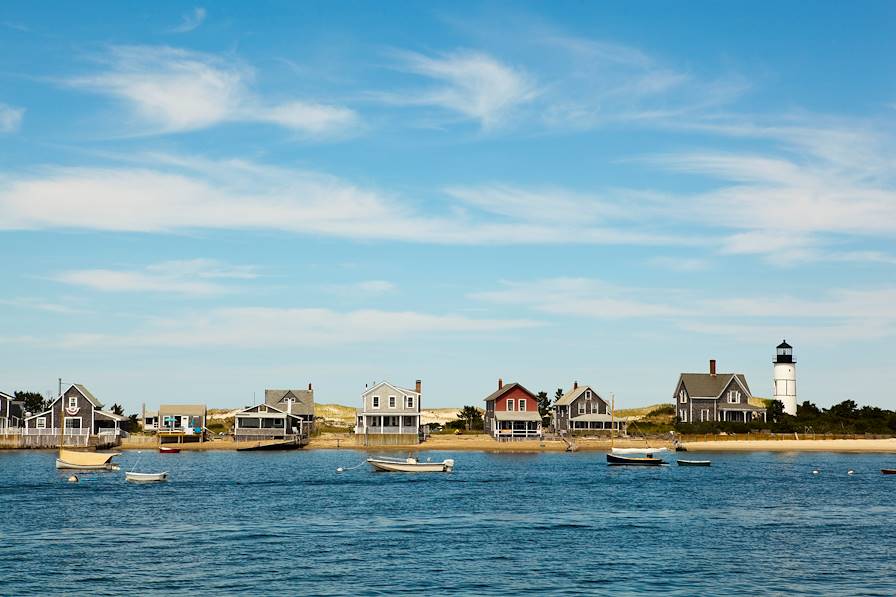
22, 384, 127, 447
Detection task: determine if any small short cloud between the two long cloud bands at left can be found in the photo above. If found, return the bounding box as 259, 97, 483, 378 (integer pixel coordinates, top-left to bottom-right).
52, 259, 257, 295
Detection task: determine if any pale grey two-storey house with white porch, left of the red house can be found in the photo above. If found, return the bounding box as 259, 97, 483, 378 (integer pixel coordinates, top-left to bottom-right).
355, 379, 423, 446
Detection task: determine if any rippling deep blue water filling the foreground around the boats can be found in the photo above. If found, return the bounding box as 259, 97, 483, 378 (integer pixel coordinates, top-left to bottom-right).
0, 450, 896, 595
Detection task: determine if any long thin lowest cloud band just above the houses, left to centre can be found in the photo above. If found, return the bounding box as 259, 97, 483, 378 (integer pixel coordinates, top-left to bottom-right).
54, 307, 539, 349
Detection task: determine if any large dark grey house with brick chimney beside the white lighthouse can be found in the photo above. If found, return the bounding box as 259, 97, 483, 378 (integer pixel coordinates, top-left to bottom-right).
673, 359, 765, 423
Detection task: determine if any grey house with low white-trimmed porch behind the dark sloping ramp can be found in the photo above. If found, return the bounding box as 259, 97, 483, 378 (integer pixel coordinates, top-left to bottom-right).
233, 384, 314, 441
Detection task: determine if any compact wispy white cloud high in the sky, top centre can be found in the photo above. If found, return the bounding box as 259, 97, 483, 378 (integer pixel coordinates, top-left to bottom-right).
380, 51, 537, 129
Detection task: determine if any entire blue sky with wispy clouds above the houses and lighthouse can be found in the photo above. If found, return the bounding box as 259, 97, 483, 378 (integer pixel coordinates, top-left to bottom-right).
0, 1, 896, 412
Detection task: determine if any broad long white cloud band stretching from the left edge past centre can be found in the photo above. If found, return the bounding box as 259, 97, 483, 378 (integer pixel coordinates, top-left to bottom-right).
0, 155, 691, 244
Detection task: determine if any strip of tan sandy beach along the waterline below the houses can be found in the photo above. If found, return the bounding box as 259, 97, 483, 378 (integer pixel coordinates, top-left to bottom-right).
119, 433, 896, 453
